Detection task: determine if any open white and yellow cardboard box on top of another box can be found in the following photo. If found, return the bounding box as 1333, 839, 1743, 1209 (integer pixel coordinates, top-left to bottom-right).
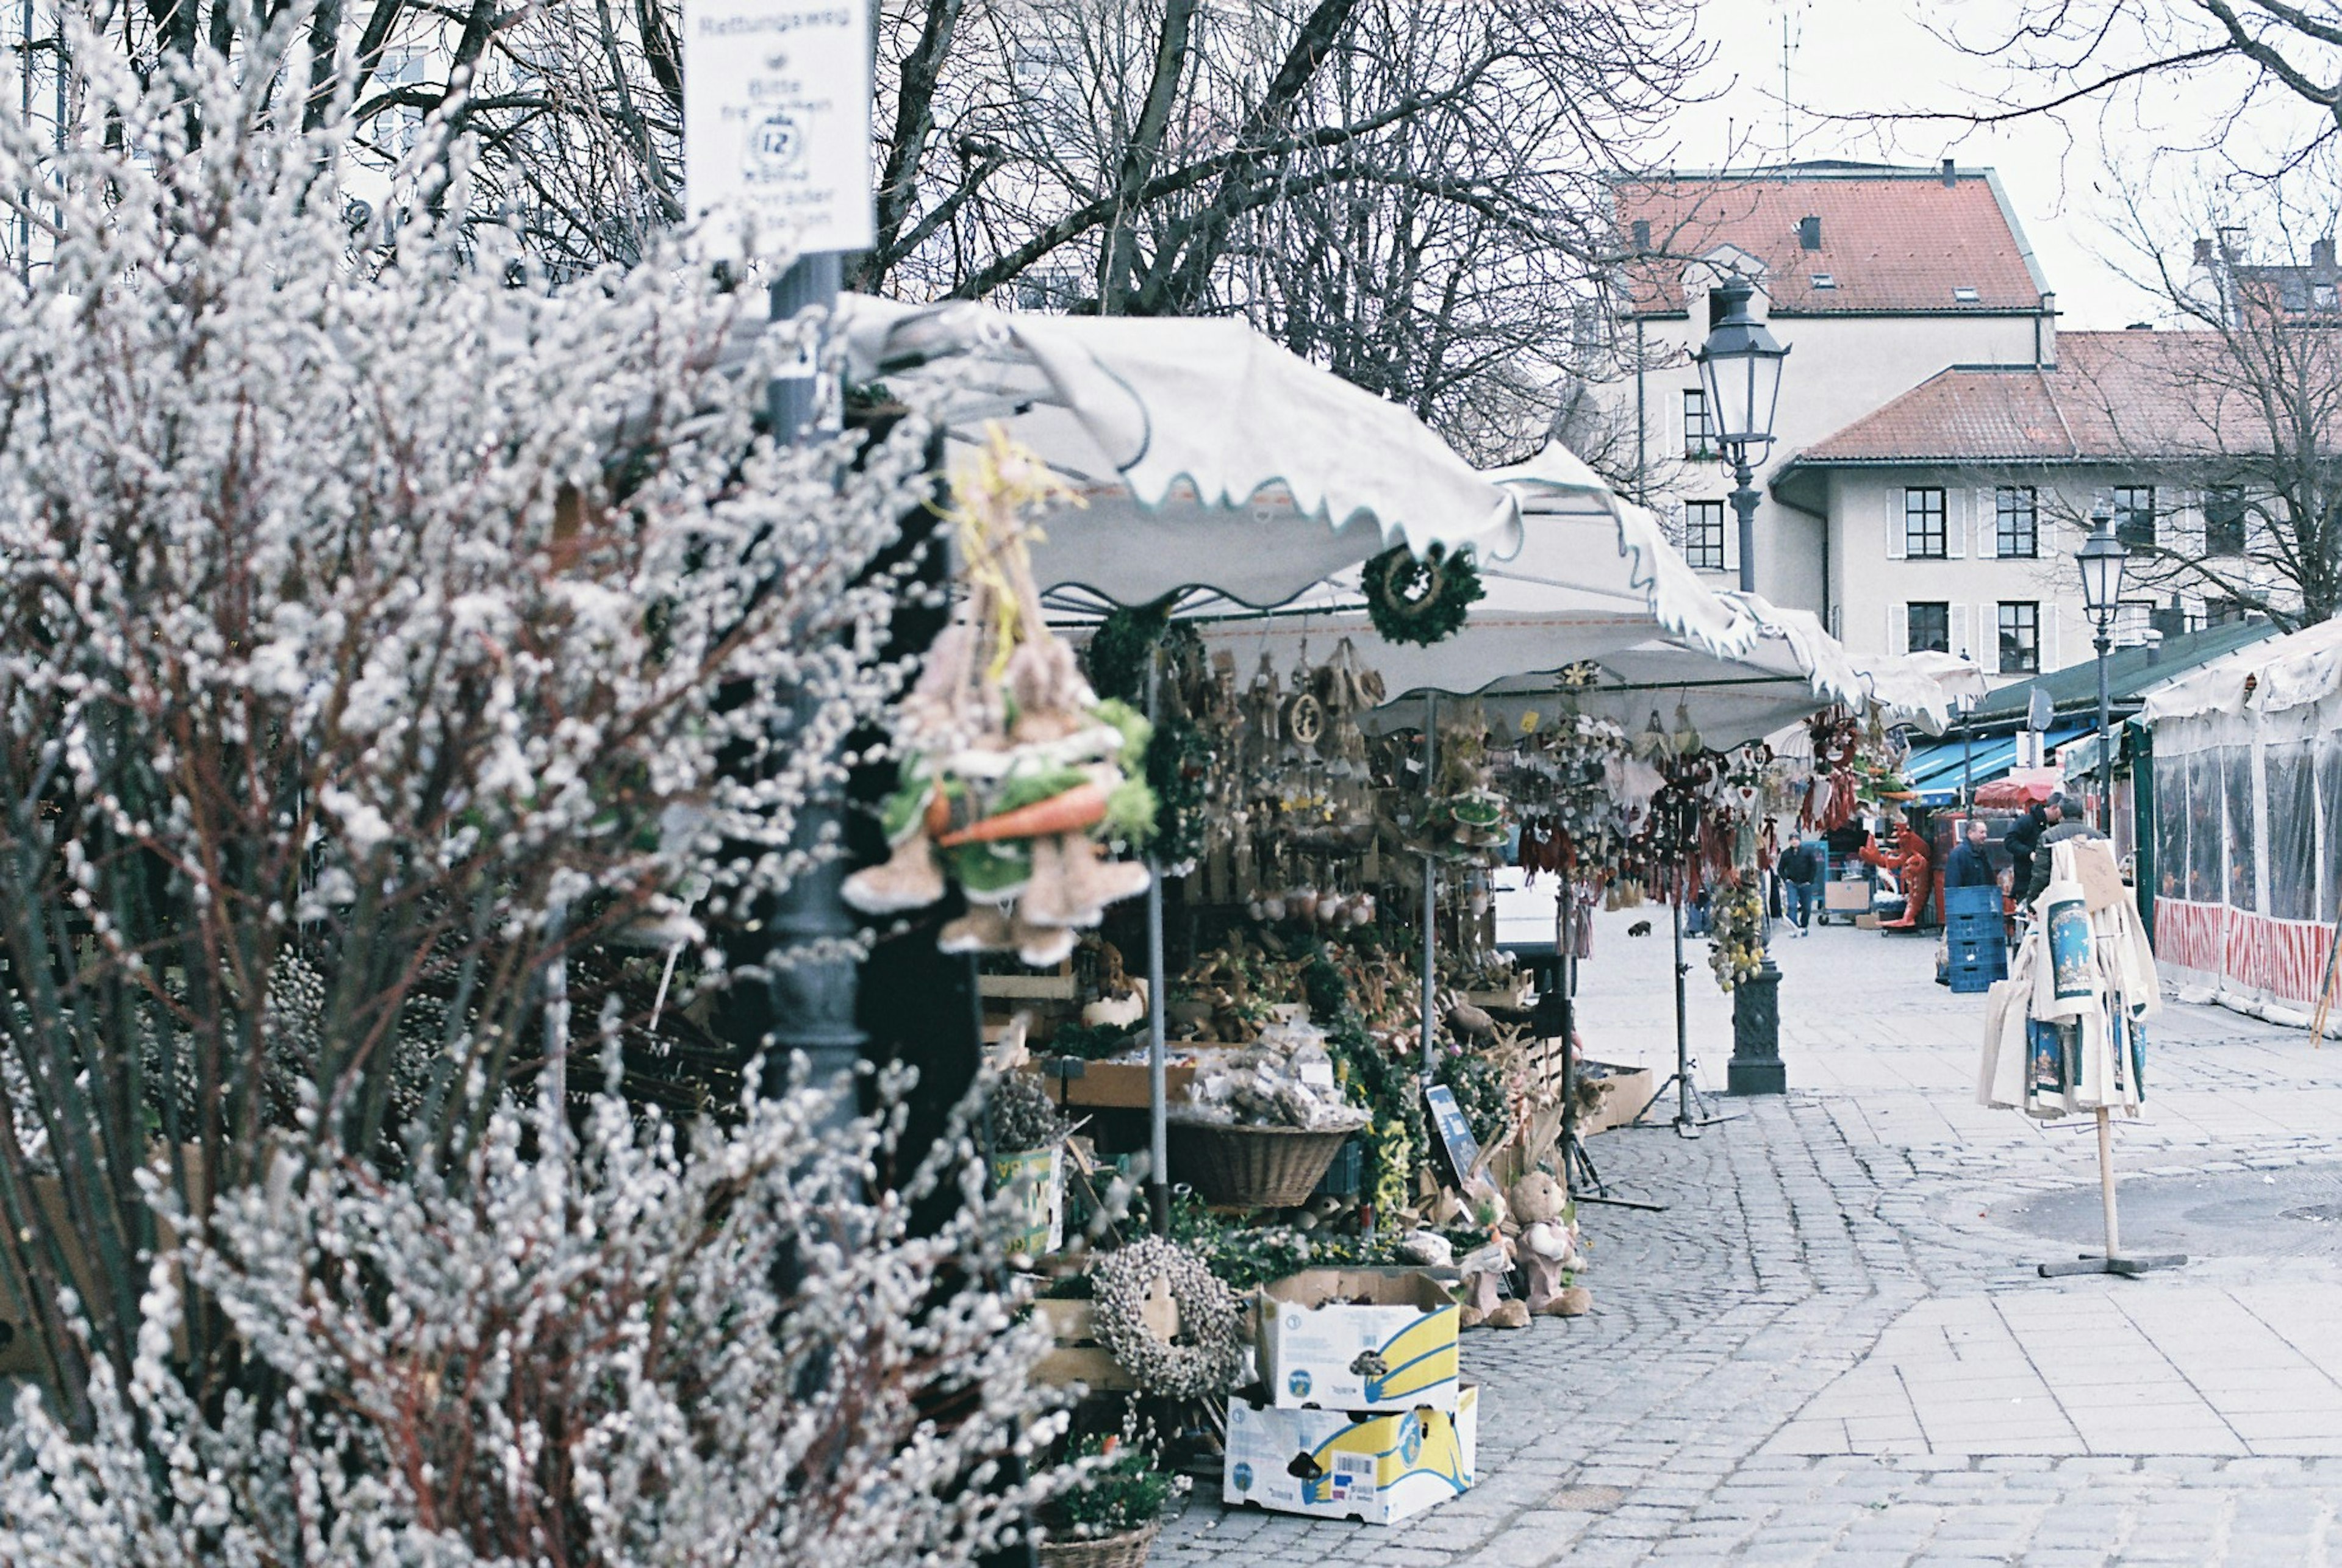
1255, 1269, 1459, 1411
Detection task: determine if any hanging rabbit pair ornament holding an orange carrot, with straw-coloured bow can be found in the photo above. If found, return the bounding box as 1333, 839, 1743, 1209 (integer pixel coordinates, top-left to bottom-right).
843, 426, 1155, 964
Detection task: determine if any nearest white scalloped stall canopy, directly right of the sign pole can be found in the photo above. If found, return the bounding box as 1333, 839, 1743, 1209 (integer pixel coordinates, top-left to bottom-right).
836, 295, 1527, 606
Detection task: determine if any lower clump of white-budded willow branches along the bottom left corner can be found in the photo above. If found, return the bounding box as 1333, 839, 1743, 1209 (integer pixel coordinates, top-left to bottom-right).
0, 1090, 1068, 1568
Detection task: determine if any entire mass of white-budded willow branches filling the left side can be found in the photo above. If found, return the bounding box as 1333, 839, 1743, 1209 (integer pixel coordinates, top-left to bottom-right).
0, 21, 1063, 1563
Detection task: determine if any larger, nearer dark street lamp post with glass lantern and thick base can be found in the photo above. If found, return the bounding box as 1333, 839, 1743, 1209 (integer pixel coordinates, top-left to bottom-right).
1698, 274, 1789, 1095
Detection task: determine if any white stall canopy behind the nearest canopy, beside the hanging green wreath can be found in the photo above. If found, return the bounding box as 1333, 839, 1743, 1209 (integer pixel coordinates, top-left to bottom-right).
1180, 447, 1953, 749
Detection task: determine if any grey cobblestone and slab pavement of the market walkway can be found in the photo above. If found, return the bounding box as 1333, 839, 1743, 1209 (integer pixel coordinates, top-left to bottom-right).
1155, 915, 2342, 1568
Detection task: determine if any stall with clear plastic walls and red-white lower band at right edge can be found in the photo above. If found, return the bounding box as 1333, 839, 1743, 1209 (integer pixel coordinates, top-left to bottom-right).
2141, 620, 2342, 1023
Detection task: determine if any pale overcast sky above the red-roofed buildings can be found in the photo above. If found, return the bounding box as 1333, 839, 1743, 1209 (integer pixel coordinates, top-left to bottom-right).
1672, 0, 2323, 328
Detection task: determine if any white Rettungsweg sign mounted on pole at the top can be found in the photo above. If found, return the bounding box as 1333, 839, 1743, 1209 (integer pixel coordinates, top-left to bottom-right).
684, 0, 876, 252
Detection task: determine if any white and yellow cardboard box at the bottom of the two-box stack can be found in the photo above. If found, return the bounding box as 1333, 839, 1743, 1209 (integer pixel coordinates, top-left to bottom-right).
1220, 1383, 1480, 1523
